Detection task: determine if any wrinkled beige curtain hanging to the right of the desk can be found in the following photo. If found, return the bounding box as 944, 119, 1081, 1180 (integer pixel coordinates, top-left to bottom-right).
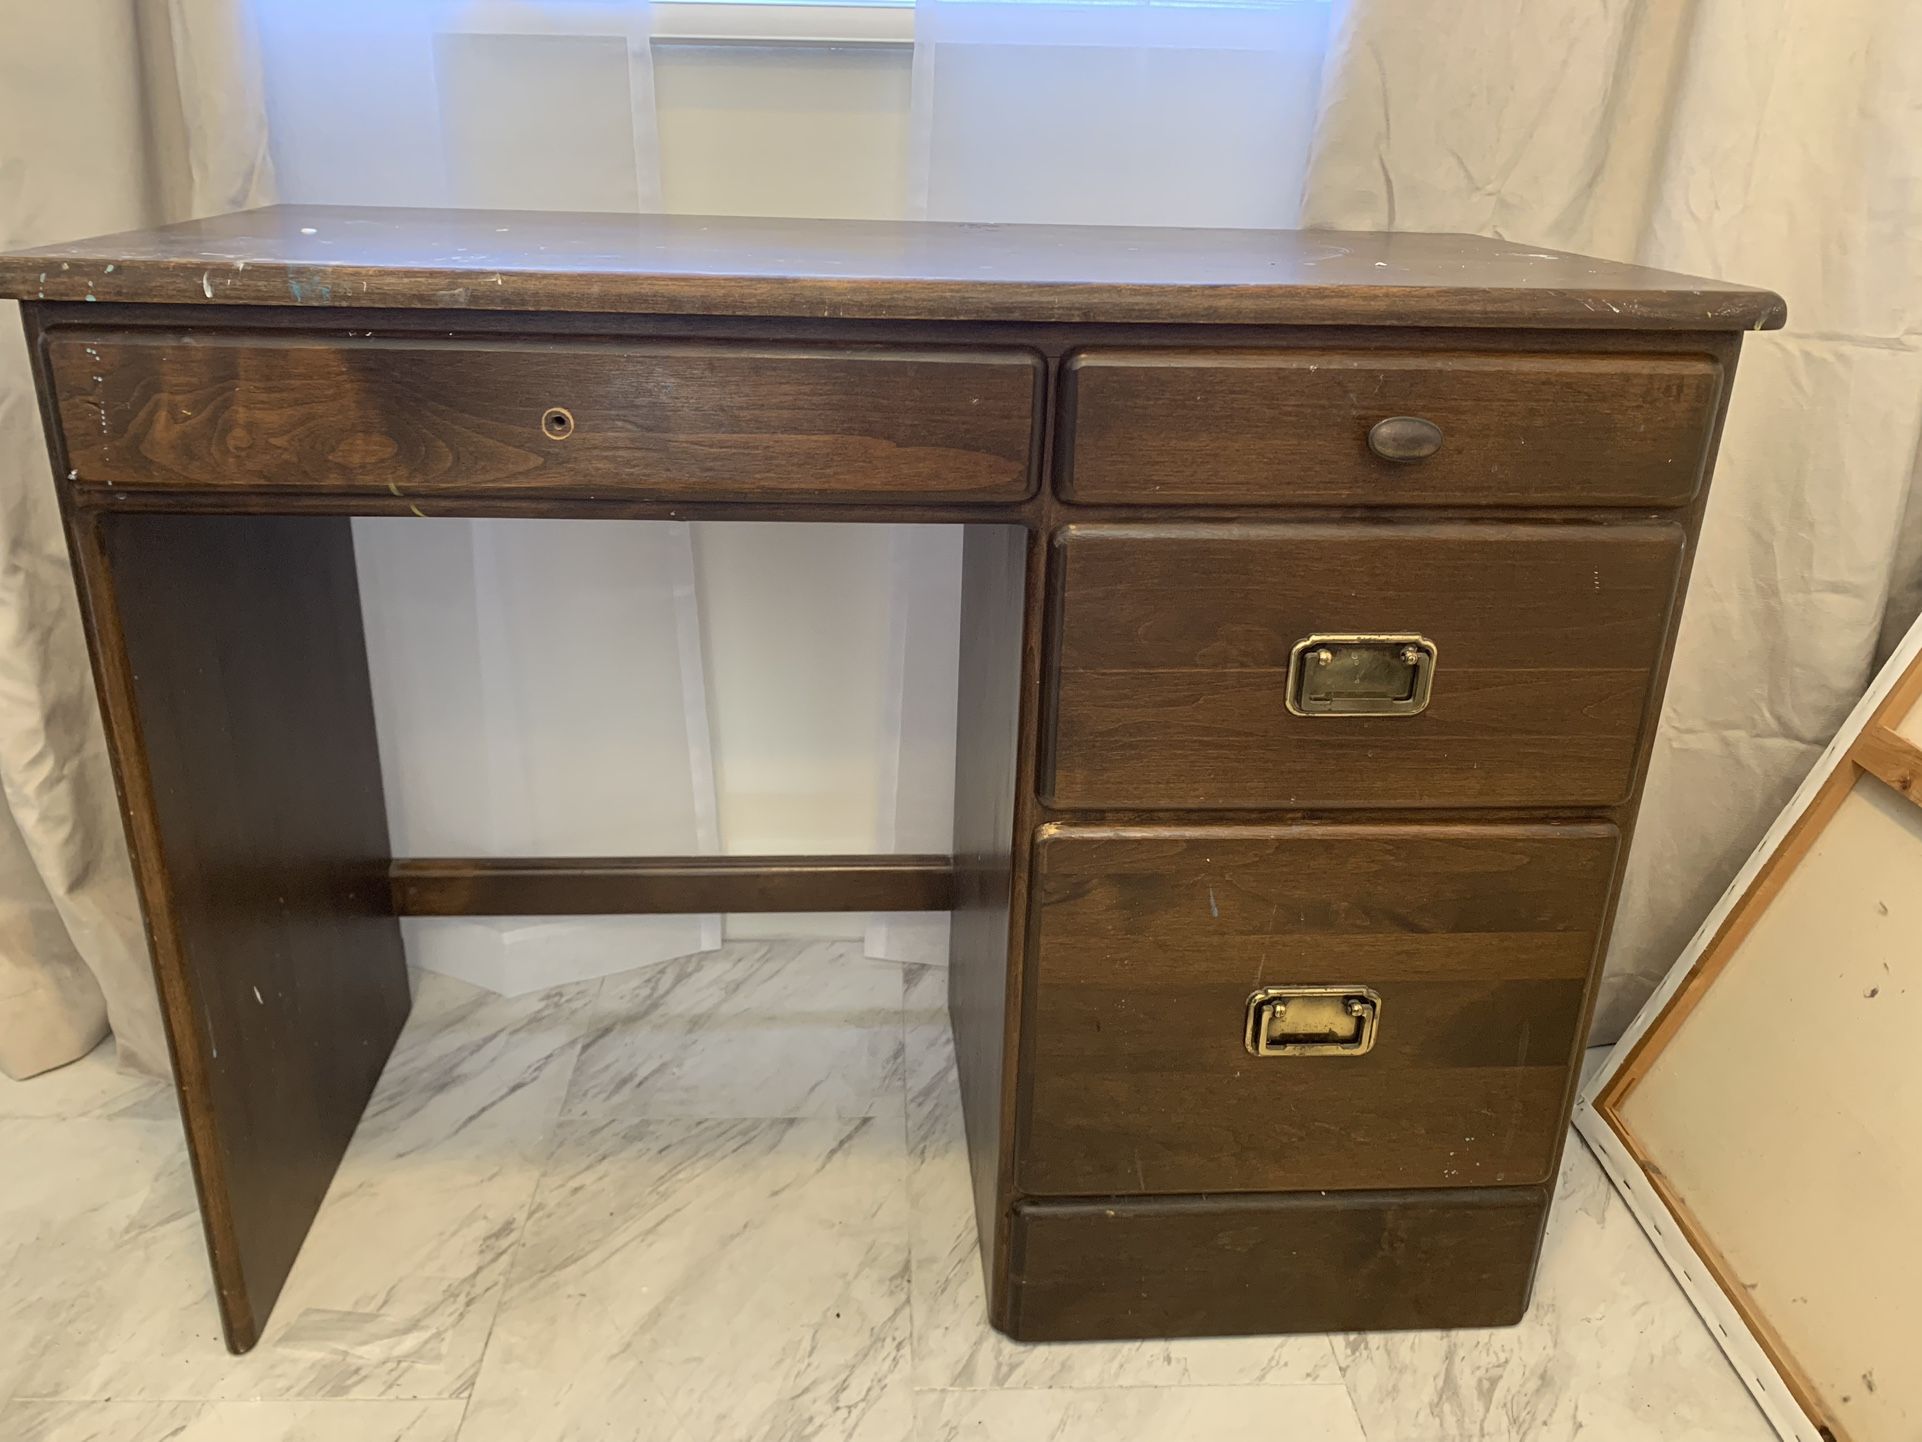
1303, 0, 1922, 1040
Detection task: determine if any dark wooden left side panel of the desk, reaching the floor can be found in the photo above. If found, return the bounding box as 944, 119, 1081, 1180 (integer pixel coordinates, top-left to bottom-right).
71, 513, 407, 1352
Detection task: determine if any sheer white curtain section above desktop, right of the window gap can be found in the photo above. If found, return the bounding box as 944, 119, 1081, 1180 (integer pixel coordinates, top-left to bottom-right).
911, 0, 1328, 227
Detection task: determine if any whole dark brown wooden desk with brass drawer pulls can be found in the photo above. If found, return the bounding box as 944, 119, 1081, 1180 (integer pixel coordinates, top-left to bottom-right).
0, 208, 1782, 1350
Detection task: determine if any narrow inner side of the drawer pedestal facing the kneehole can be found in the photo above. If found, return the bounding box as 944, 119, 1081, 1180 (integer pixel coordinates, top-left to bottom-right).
948, 525, 1046, 1321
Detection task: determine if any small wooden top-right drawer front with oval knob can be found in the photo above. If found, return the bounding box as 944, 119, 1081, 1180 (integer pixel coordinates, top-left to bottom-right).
1059, 348, 1722, 506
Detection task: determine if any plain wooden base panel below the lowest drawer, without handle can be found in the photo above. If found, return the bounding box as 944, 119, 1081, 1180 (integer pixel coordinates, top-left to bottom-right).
1007, 1186, 1549, 1342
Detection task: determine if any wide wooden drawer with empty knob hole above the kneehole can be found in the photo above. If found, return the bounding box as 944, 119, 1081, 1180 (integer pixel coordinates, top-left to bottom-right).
50, 331, 1044, 502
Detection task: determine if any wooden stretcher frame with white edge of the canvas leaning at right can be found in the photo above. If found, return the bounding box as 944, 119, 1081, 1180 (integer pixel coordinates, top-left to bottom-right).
1574, 621, 1922, 1442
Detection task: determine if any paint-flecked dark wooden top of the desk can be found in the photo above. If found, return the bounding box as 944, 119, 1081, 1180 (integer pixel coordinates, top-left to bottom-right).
0, 206, 1784, 331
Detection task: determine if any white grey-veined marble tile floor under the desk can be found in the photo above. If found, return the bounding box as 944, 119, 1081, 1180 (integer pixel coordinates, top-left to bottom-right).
0, 942, 1770, 1442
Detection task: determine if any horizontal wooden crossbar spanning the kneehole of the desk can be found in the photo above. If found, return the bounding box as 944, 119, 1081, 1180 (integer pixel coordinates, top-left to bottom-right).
390, 856, 953, 917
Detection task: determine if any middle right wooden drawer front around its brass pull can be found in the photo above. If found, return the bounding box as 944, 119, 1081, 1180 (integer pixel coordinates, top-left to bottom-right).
1047, 523, 1682, 808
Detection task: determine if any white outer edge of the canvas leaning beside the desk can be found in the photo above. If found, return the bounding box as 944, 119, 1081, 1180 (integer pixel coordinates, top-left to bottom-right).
1574, 619, 1922, 1442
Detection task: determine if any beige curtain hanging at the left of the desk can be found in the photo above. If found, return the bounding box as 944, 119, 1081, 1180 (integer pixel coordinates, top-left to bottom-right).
0, 0, 273, 1077
